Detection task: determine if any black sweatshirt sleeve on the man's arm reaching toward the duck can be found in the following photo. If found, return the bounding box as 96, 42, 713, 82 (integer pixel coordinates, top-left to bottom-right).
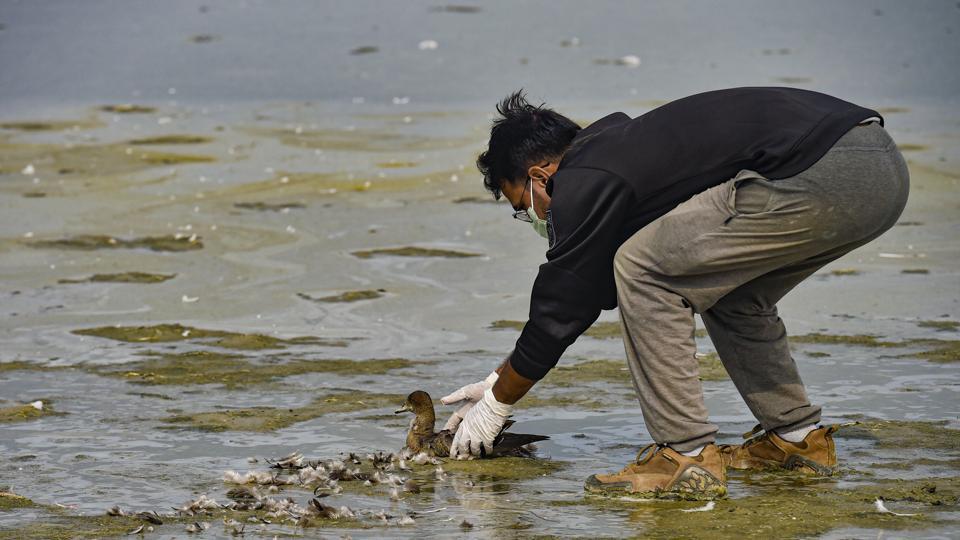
510, 168, 634, 380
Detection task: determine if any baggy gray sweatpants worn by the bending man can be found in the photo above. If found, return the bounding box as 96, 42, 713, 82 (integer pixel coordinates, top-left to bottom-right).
614, 124, 909, 451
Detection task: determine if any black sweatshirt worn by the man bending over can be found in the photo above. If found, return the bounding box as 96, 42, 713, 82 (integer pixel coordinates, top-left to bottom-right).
510, 87, 882, 379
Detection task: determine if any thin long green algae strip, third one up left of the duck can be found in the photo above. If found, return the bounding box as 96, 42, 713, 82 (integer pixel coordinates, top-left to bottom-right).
72, 324, 346, 350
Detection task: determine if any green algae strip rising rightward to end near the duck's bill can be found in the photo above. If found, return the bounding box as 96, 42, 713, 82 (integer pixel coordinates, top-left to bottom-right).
163, 390, 406, 432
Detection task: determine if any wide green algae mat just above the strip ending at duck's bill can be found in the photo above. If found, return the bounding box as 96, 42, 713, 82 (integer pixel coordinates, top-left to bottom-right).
91, 351, 416, 389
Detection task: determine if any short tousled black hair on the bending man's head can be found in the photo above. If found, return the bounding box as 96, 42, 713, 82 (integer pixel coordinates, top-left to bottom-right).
477, 89, 580, 200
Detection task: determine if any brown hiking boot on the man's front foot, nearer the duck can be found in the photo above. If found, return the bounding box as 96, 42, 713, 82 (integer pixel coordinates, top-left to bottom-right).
584, 444, 727, 500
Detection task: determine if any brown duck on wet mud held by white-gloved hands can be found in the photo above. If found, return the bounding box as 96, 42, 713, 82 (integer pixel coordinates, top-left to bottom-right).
394, 390, 550, 457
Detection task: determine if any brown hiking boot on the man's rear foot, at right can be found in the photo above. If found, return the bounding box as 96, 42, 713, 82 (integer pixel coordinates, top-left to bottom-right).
720, 424, 843, 476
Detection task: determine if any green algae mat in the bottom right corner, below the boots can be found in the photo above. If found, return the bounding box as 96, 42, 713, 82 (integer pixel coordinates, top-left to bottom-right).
549, 478, 960, 539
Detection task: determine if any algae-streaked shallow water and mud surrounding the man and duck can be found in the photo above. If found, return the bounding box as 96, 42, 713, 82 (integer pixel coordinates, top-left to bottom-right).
0, 0, 960, 540
